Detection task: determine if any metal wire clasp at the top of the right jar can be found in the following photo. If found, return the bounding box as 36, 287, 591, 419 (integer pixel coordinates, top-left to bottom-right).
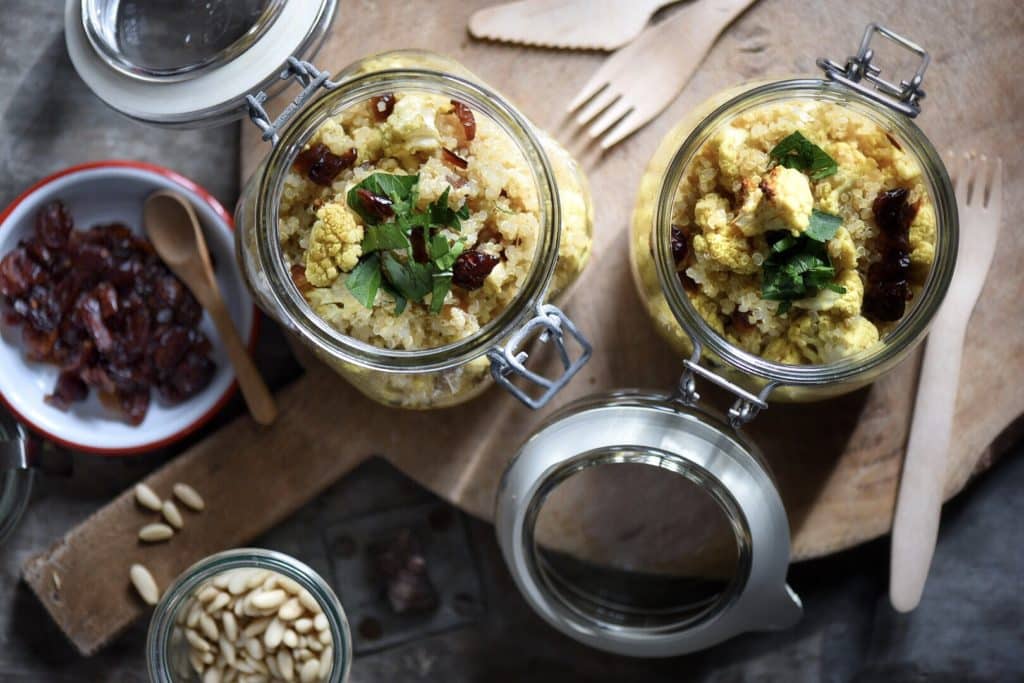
817, 24, 931, 119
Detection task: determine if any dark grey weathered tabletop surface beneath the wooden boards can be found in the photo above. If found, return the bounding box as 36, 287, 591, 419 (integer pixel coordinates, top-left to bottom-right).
0, 0, 1024, 683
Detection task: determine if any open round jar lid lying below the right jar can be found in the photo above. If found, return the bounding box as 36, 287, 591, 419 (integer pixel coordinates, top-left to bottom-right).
495, 391, 802, 656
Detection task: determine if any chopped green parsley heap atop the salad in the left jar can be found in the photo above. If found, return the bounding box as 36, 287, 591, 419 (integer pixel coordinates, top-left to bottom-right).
345, 173, 469, 314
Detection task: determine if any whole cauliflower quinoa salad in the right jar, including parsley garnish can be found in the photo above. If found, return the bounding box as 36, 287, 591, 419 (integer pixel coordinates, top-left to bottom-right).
633, 100, 936, 365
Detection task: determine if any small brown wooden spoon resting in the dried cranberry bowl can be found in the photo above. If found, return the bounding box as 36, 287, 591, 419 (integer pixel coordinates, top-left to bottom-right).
142, 190, 278, 425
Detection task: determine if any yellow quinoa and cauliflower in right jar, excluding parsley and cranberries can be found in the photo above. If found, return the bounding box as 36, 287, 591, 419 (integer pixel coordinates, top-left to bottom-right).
633, 100, 935, 364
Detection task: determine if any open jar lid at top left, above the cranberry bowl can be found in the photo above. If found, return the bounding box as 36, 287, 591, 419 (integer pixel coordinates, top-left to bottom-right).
65, 0, 337, 126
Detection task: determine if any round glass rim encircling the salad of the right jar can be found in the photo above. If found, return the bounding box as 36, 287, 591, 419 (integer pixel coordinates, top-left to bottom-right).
652, 78, 958, 390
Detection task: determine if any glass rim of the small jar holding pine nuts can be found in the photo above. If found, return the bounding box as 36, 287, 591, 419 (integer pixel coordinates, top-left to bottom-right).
145, 548, 352, 683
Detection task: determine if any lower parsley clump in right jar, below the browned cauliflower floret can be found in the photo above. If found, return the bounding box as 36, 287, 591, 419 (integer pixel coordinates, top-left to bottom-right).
761, 209, 846, 314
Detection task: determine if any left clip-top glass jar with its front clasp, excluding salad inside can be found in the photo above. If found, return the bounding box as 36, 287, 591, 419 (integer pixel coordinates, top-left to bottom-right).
236, 51, 593, 409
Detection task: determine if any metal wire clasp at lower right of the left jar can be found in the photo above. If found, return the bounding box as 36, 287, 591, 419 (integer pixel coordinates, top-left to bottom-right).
487, 304, 594, 410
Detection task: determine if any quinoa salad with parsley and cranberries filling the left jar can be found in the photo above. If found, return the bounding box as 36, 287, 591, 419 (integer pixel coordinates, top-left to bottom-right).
279, 91, 591, 408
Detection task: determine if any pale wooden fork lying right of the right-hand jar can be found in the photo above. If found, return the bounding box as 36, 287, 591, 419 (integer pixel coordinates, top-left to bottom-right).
889, 156, 1002, 612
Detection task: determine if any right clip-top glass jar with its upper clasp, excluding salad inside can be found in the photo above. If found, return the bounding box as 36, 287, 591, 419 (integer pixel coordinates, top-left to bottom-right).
631, 25, 957, 401
